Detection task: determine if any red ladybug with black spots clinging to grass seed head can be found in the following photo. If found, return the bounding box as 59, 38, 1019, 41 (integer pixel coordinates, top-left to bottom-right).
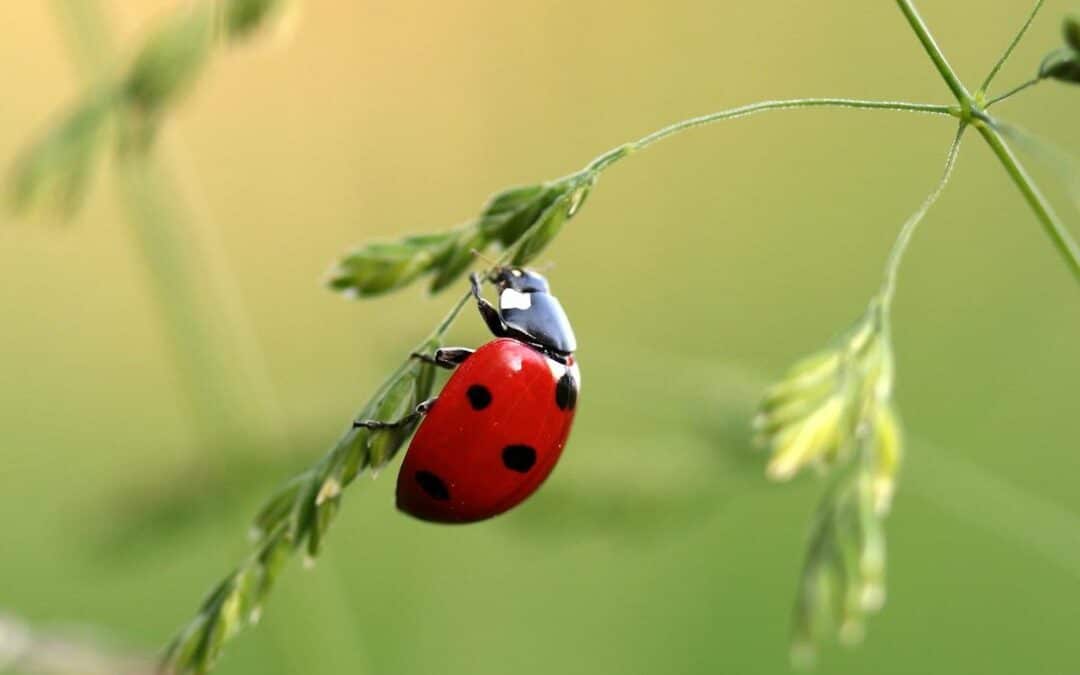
353, 266, 581, 523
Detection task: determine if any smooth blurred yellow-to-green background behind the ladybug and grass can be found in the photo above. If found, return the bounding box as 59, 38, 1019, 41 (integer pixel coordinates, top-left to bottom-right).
0, 0, 1080, 675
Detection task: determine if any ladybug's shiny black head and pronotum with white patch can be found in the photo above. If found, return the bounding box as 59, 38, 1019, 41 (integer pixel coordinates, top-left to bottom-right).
490, 267, 578, 360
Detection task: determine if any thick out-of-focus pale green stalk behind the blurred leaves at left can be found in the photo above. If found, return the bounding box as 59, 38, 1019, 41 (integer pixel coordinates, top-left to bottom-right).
53, 0, 283, 457
